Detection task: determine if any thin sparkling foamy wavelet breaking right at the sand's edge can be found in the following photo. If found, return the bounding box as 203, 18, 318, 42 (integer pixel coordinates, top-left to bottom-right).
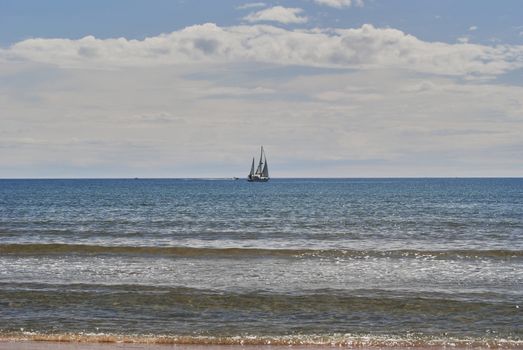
0, 332, 523, 349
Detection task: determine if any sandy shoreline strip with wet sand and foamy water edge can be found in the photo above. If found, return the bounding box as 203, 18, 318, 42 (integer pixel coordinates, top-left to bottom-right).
0, 332, 523, 350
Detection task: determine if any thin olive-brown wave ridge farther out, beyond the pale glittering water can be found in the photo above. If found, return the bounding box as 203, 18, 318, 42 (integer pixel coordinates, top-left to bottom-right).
0, 243, 523, 259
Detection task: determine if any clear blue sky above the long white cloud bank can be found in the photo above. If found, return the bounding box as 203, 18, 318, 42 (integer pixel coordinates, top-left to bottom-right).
4, 0, 523, 46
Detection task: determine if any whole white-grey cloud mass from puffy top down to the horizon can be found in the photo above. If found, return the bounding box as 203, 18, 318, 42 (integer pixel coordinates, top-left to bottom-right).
0, 24, 523, 177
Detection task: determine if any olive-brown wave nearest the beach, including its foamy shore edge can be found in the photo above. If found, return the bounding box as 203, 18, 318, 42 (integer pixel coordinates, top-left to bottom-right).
0, 283, 523, 348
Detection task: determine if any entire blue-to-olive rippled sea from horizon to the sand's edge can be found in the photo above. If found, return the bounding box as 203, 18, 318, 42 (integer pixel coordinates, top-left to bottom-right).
0, 178, 523, 348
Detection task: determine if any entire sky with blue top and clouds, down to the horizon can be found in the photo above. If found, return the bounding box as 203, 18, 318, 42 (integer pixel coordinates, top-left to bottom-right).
0, 0, 523, 178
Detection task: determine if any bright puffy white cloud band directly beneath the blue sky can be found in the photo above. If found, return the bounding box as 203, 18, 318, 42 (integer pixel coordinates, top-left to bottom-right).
5, 23, 523, 77
